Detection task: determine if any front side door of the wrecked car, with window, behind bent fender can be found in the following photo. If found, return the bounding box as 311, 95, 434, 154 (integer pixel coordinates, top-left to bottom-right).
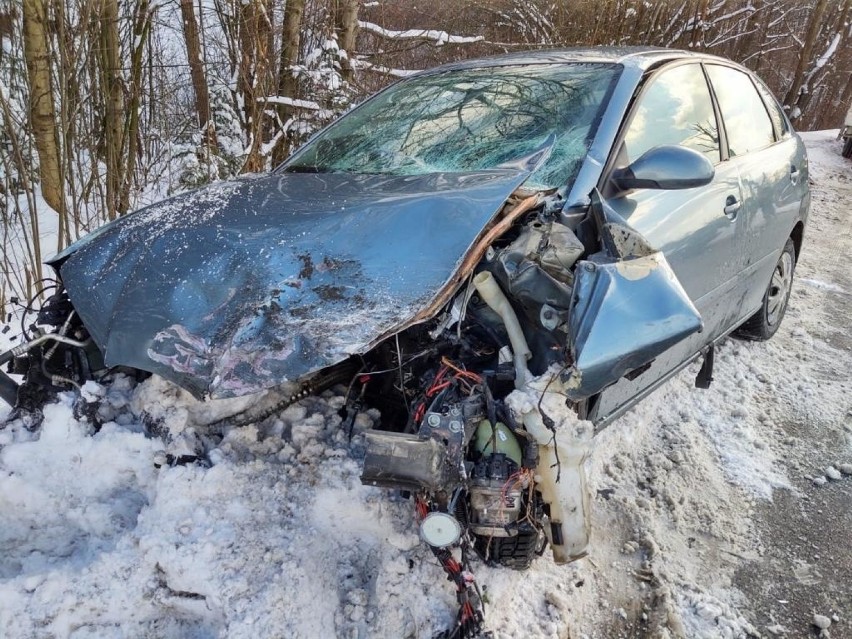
589, 62, 743, 422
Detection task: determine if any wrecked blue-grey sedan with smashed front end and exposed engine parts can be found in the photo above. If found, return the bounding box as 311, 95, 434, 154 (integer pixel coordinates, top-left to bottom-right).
0, 49, 809, 636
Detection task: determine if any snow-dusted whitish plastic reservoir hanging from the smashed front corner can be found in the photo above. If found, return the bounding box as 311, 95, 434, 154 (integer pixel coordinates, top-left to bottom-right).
506, 369, 592, 564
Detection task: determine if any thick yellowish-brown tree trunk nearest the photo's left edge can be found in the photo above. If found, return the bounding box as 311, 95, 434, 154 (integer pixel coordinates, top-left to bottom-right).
23, 0, 67, 232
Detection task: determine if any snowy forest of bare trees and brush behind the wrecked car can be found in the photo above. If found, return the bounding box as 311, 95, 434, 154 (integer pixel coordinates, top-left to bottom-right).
0, 0, 852, 311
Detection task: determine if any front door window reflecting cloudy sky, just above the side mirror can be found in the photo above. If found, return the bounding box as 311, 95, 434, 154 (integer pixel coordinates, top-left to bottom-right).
624, 64, 720, 164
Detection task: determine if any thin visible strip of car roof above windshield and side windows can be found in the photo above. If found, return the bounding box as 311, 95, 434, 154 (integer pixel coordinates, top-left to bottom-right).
425, 47, 722, 73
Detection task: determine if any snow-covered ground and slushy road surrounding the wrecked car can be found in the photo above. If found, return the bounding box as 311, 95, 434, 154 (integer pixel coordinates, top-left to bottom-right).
0, 132, 852, 639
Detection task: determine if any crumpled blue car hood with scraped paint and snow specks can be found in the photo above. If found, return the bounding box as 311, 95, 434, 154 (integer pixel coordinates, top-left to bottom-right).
48, 170, 528, 397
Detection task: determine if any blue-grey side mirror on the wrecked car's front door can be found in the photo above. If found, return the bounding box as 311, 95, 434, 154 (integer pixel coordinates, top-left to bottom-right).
612, 144, 716, 191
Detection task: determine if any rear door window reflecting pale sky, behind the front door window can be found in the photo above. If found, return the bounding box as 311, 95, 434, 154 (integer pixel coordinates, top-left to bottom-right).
707, 64, 775, 157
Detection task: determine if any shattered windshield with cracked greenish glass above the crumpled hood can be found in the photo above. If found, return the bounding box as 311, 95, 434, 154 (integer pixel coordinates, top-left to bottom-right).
284, 64, 621, 188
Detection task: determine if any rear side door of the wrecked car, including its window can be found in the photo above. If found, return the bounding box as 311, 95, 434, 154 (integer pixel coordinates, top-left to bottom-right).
705, 64, 807, 326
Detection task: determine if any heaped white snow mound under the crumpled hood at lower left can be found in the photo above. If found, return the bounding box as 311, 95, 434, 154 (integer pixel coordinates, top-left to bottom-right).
0, 379, 466, 637
